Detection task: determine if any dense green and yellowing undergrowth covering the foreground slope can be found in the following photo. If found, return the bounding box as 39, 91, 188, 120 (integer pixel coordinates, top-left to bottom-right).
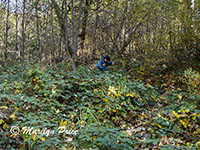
0, 63, 200, 150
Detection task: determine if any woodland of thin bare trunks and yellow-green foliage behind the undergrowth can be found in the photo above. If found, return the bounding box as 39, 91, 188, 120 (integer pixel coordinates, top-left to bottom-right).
0, 0, 200, 69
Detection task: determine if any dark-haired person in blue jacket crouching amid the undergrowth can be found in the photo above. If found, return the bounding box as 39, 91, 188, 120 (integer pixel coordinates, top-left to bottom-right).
96, 56, 112, 71
